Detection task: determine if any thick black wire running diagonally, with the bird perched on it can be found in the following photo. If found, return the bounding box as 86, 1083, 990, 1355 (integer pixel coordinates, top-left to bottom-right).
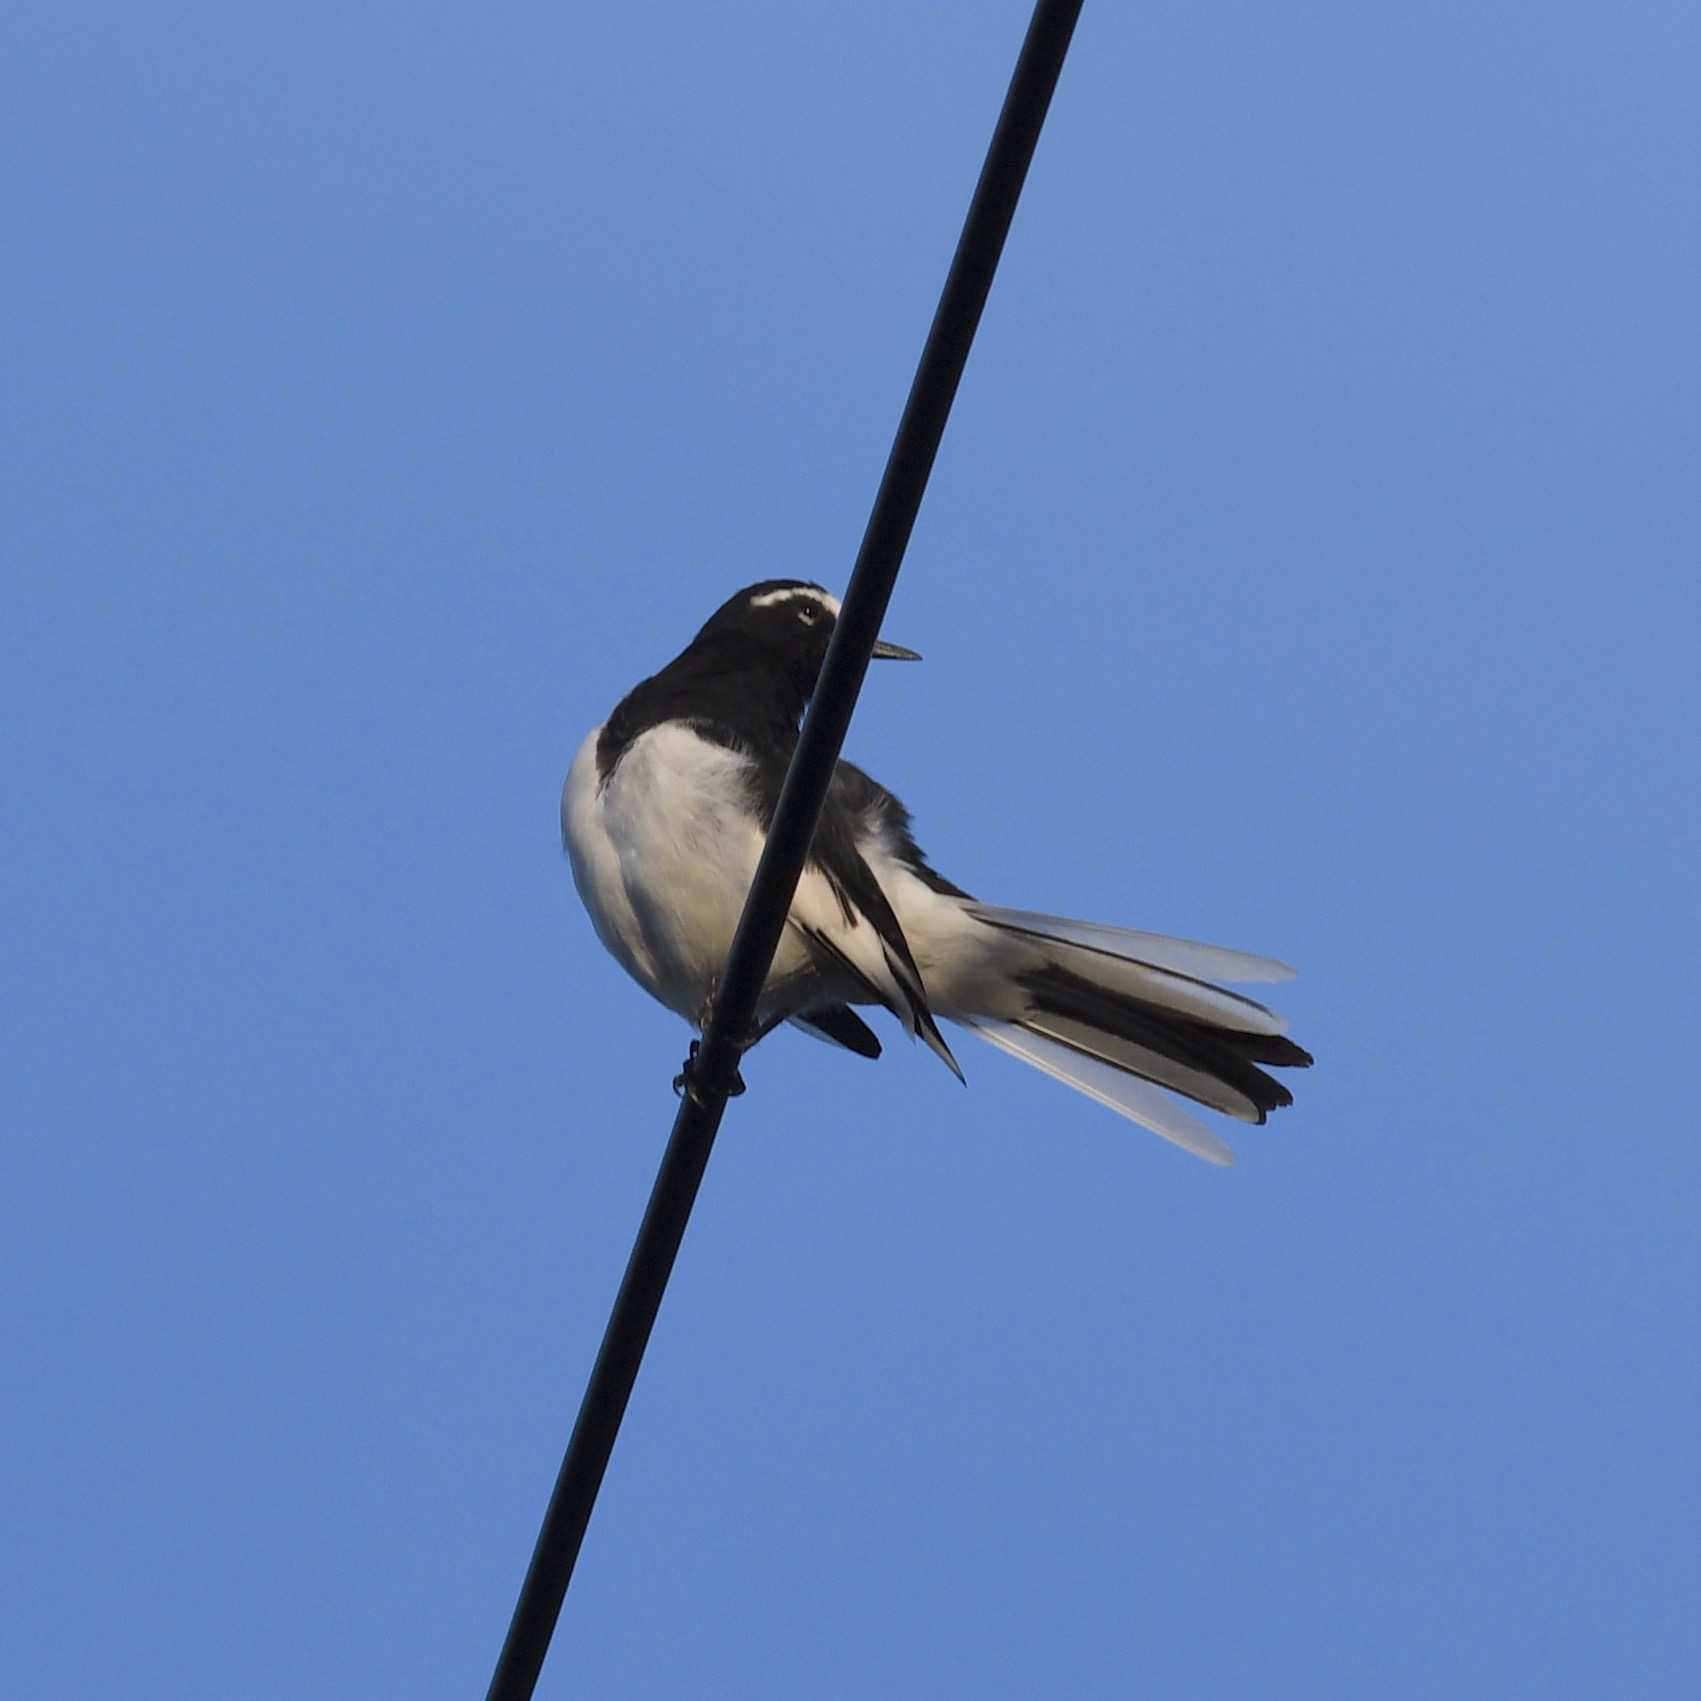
488, 0, 1080, 1701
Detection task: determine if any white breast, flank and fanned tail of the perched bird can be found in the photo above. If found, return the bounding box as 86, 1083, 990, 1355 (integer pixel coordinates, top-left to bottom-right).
561, 683, 1310, 1163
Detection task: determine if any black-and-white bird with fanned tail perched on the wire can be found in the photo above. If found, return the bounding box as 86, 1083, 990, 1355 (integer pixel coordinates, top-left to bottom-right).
561, 578, 1311, 1163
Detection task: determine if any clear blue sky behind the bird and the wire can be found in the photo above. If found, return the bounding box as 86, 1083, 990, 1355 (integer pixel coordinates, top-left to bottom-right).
0, 0, 1701, 1701
